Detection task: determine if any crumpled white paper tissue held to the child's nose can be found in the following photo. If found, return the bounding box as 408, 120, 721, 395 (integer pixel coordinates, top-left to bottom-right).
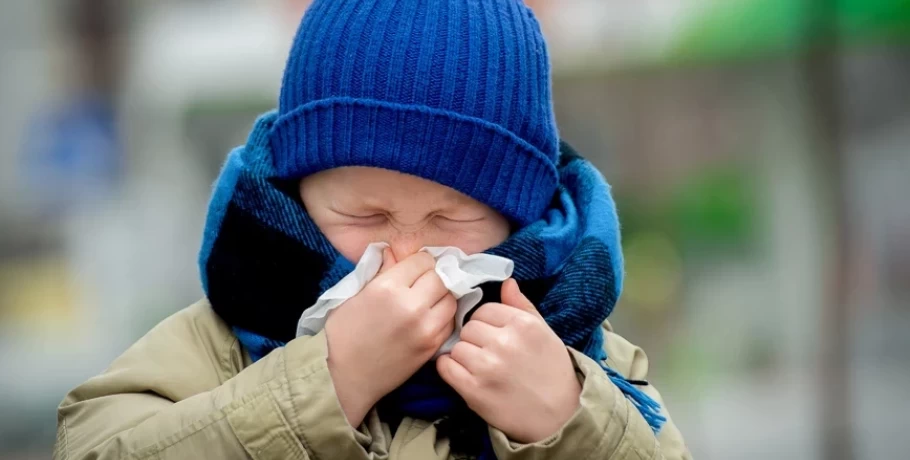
297, 243, 514, 356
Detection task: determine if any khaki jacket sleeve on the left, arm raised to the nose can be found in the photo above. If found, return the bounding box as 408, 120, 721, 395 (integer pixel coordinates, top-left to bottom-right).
54, 307, 382, 460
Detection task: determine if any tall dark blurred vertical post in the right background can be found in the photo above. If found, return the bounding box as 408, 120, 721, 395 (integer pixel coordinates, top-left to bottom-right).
803, 0, 856, 460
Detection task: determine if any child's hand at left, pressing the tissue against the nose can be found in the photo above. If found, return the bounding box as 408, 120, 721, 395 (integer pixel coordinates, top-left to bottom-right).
325, 249, 456, 426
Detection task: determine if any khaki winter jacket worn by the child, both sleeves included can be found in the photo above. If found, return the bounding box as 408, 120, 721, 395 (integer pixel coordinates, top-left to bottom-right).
54, 301, 691, 460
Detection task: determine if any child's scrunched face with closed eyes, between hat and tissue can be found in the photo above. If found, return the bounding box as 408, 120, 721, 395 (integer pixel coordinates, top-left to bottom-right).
300, 167, 509, 262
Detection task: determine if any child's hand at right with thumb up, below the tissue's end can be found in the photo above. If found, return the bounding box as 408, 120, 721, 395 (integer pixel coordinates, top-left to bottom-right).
436, 279, 581, 443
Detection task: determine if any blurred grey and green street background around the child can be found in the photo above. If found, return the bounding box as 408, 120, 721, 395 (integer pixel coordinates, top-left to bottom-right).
0, 0, 910, 460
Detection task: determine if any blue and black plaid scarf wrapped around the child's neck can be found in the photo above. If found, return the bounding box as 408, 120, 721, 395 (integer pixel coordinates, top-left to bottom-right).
199, 112, 666, 458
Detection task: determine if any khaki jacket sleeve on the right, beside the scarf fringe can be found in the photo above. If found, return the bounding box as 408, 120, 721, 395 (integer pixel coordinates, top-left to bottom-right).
490, 325, 692, 460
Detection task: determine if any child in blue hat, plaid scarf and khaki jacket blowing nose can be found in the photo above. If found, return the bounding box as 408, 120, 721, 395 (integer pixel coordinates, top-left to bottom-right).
55, 0, 689, 460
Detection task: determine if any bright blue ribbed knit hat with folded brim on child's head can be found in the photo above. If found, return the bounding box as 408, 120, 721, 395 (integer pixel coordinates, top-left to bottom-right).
270, 0, 559, 225
